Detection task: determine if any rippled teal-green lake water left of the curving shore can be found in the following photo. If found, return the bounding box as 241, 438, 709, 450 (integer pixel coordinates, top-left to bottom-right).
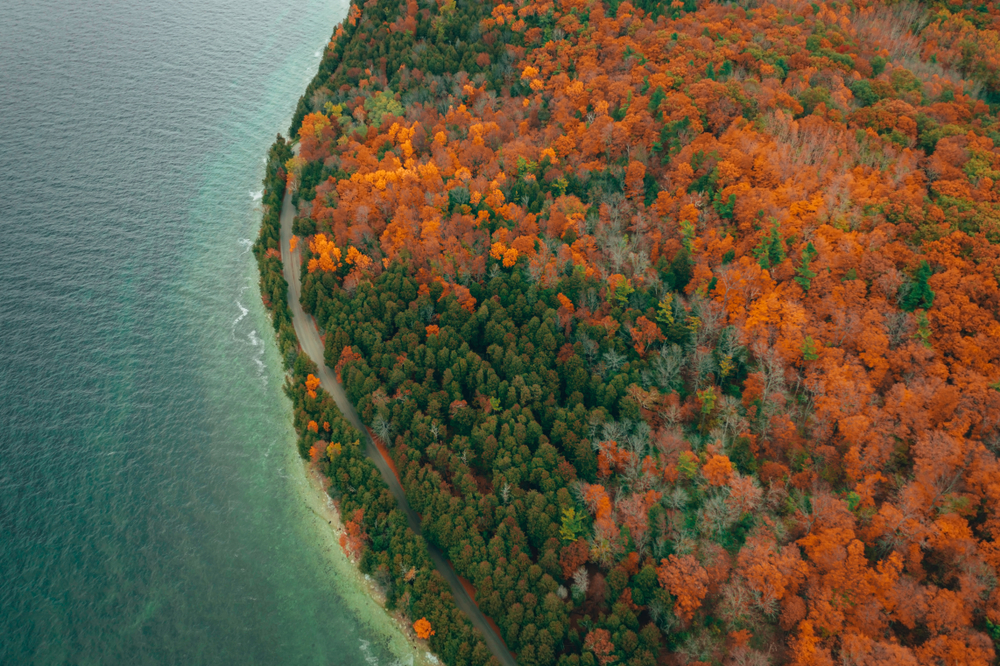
0, 0, 420, 664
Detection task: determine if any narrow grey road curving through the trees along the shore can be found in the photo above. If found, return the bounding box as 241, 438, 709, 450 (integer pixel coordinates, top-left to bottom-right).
281, 153, 517, 666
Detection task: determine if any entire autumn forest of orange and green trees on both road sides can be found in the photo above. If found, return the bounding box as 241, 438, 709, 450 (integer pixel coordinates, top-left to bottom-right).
255, 0, 1000, 666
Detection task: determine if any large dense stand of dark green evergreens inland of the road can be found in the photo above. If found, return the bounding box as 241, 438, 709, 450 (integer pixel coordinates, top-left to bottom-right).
302, 260, 728, 665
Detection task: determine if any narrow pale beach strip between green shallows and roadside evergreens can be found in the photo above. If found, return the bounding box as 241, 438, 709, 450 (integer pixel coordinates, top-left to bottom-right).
301, 460, 441, 666
